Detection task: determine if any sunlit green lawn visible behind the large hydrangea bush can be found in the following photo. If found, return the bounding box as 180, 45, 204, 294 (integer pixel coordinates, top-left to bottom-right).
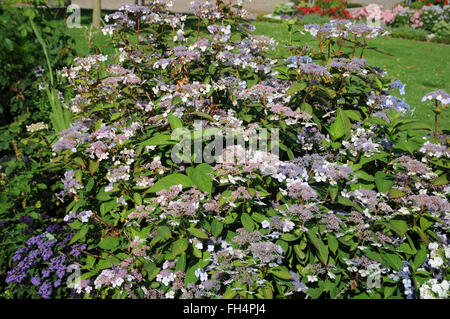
61, 16, 450, 130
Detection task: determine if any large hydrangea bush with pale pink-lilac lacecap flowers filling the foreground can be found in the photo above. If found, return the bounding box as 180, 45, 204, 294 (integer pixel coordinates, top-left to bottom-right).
3, 0, 450, 299
